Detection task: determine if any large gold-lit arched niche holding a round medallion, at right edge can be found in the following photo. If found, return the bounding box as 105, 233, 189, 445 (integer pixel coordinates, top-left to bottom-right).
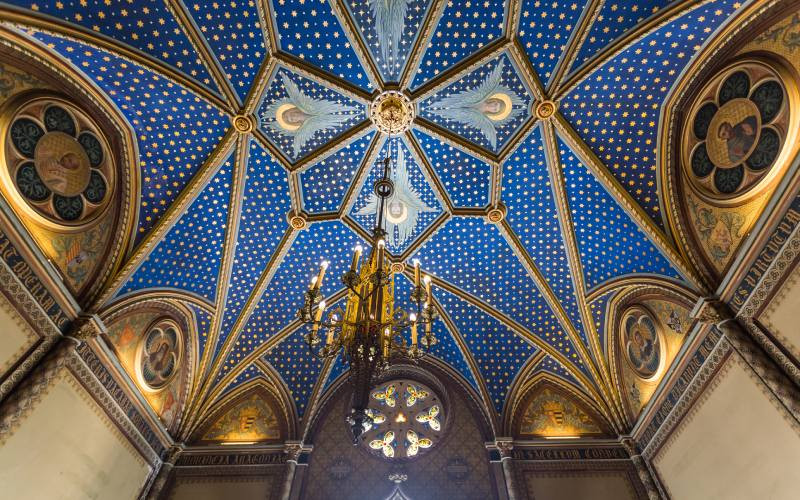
659, 2, 800, 288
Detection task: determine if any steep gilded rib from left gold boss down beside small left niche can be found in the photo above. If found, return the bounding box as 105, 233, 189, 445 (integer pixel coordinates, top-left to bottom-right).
195, 134, 250, 389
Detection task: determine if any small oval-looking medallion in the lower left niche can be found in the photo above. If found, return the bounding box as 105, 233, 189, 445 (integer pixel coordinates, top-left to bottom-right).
136, 319, 183, 391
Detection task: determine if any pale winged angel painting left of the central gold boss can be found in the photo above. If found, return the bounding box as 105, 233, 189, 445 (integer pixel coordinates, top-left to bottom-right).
261, 72, 360, 157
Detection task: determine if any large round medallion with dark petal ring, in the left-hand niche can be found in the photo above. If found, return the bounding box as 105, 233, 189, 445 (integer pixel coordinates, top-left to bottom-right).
4, 95, 115, 226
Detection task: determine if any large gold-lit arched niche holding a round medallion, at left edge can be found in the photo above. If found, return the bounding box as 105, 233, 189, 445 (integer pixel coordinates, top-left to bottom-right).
0, 30, 139, 305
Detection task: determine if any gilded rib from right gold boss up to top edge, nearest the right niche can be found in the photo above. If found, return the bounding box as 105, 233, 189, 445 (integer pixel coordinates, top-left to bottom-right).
551, 0, 707, 100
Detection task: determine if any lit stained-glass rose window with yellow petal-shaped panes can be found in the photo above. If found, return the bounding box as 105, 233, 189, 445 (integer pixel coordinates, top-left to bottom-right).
362, 380, 445, 459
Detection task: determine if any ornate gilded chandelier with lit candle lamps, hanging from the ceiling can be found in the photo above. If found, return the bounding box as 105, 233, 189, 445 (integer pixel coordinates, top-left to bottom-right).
298, 157, 439, 443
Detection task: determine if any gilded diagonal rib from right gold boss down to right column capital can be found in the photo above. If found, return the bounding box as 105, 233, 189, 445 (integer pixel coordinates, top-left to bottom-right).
552, 111, 709, 293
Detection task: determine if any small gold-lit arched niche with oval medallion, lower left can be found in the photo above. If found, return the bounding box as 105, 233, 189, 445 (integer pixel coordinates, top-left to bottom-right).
100, 292, 199, 435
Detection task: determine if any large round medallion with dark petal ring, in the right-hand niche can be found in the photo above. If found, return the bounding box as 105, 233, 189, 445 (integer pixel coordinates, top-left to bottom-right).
682, 60, 791, 202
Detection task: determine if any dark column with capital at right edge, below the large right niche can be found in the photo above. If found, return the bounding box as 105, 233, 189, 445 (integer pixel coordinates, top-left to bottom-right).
692, 297, 800, 422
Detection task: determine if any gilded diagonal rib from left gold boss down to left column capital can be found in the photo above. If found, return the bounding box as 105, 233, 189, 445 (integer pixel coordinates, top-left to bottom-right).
89, 127, 238, 312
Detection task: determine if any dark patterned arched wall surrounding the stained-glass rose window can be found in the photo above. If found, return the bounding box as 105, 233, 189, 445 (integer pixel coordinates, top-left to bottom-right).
302, 360, 496, 499
